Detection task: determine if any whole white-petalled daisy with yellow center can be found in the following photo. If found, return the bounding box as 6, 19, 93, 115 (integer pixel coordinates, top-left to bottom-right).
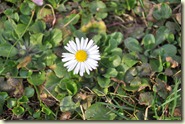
62, 37, 100, 76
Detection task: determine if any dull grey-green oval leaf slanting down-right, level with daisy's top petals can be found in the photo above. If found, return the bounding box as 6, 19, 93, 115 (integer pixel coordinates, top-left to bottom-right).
124, 37, 142, 52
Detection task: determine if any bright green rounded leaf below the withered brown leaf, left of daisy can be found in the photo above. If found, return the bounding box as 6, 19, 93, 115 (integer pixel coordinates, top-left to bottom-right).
28, 71, 46, 86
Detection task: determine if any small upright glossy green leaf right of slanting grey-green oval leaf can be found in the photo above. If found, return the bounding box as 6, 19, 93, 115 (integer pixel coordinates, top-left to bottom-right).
142, 34, 155, 49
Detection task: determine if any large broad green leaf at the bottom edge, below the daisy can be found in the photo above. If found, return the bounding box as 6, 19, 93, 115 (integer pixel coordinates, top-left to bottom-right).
85, 102, 116, 120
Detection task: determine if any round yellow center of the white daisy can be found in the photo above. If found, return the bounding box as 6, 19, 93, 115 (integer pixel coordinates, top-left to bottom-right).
75, 50, 88, 62
